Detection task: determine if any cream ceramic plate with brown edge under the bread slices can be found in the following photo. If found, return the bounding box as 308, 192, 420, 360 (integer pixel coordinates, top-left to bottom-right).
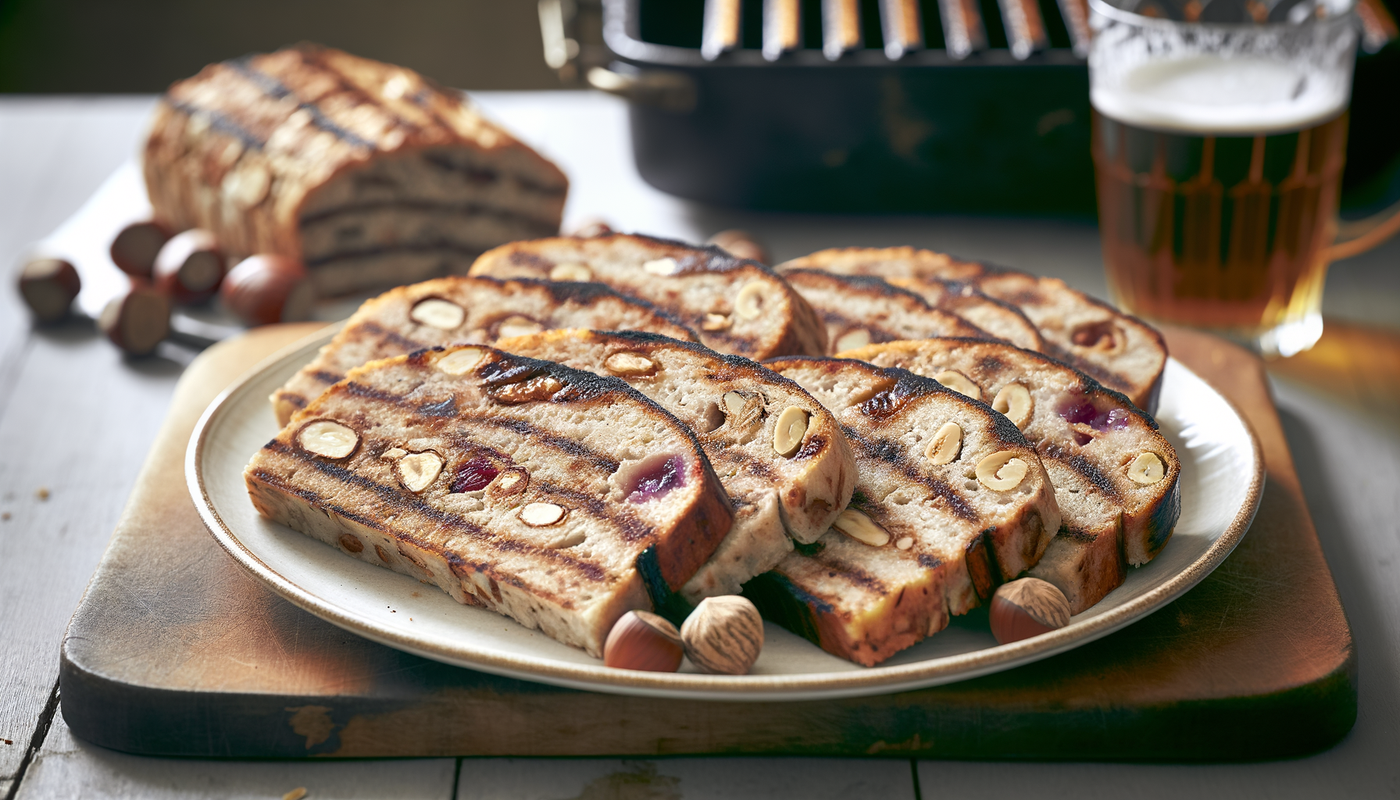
186, 332, 1263, 701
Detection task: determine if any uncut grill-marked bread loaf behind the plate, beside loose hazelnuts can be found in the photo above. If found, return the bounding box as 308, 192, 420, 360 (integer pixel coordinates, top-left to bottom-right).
144, 45, 568, 296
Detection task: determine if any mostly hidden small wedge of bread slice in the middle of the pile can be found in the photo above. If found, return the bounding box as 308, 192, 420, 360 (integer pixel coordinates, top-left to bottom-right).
783, 269, 988, 353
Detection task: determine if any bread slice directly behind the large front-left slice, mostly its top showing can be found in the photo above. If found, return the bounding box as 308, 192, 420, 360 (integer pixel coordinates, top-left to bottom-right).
272, 276, 694, 425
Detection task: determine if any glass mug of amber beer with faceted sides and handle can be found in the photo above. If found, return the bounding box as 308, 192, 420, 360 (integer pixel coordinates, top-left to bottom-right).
1089, 0, 1400, 356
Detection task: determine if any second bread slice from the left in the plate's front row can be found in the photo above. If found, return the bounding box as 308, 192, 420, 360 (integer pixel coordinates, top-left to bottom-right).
498, 331, 855, 604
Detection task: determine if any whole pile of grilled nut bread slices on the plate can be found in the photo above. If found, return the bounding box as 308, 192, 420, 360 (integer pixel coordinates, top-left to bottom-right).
246, 233, 1180, 665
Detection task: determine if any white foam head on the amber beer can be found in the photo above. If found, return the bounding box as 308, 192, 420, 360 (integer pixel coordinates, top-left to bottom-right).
1091, 55, 1351, 135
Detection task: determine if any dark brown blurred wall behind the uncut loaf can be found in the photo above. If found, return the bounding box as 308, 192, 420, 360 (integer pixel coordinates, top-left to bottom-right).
0, 0, 560, 94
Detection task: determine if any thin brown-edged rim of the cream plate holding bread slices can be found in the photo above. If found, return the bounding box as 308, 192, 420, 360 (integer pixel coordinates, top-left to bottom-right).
185, 325, 1264, 701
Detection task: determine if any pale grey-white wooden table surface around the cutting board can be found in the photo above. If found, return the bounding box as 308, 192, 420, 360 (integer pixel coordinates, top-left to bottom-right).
0, 92, 1400, 800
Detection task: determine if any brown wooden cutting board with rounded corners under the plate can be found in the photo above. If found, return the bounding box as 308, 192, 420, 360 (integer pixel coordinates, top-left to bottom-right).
60, 325, 1357, 761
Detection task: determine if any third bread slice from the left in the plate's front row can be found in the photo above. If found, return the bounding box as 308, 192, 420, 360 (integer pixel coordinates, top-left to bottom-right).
745, 357, 1060, 665
